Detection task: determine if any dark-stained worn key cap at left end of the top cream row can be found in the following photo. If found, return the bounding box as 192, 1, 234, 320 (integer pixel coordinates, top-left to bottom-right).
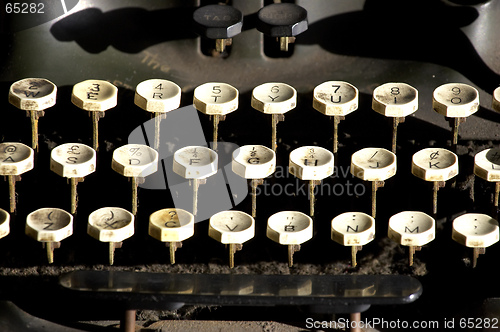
9, 78, 57, 111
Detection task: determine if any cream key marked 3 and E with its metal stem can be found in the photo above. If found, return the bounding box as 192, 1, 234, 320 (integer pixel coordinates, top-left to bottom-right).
71, 80, 118, 151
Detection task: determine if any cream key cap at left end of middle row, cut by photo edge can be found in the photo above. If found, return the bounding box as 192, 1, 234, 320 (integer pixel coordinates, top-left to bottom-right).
0, 142, 34, 176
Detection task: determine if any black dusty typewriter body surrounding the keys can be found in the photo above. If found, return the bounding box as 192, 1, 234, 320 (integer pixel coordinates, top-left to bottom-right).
0, 0, 500, 331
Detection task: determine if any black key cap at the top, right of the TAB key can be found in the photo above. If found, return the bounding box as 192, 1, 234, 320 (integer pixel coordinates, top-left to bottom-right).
257, 3, 308, 37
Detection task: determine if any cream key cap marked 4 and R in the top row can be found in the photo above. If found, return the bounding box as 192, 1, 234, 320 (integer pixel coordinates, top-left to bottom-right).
134, 79, 181, 113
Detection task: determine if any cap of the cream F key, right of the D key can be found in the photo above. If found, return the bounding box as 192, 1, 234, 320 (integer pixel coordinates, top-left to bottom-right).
174, 146, 218, 179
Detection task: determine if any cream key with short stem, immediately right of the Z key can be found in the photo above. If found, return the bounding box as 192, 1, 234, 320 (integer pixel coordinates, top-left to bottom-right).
87, 207, 134, 265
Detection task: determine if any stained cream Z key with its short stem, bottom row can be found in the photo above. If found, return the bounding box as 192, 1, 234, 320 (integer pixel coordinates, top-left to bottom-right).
25, 208, 73, 264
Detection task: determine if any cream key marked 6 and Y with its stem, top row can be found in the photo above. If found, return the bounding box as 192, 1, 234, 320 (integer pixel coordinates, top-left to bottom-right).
251, 83, 297, 151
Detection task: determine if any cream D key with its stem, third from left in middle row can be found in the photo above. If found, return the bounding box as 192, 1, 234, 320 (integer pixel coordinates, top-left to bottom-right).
111, 144, 158, 215
